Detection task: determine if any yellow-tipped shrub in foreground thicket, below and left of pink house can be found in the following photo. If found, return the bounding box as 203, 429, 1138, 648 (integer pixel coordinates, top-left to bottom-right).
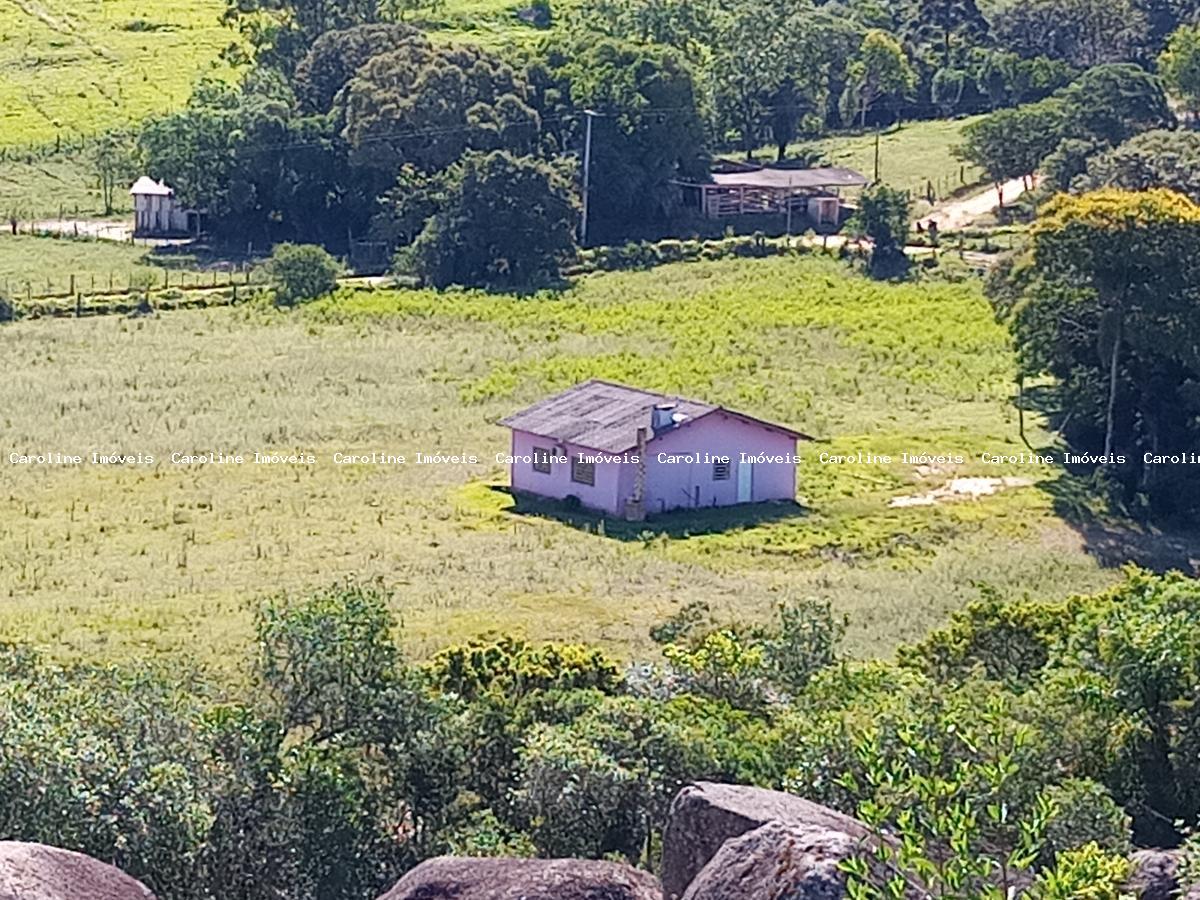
426, 635, 620, 700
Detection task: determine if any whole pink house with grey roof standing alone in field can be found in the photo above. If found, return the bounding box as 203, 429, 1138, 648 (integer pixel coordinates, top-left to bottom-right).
500, 379, 810, 521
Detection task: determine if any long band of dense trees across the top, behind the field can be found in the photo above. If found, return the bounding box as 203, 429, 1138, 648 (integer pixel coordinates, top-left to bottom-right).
77, 0, 1196, 286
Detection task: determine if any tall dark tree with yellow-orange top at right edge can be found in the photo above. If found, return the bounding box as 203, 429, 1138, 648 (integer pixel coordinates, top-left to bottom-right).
1013, 190, 1200, 504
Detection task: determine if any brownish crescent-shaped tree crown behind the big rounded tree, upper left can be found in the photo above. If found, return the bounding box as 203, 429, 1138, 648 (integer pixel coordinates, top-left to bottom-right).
294, 23, 428, 113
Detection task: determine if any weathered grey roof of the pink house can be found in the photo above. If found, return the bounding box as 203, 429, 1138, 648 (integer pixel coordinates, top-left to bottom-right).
500, 378, 811, 454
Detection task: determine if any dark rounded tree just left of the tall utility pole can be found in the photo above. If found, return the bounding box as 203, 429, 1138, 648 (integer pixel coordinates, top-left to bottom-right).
398, 150, 577, 287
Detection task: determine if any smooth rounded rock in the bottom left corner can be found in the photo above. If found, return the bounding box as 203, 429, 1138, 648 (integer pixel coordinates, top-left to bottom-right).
0, 841, 154, 900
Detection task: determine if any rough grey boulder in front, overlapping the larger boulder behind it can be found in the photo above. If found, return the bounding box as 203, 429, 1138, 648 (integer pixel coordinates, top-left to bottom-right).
683, 822, 858, 900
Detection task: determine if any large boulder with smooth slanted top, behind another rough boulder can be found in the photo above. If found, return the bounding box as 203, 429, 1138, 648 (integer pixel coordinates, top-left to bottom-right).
662, 781, 868, 900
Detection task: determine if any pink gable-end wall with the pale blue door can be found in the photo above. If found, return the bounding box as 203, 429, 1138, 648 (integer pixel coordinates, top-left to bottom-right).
618, 412, 796, 515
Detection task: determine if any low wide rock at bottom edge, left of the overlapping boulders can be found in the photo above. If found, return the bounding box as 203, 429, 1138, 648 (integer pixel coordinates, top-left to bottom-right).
379, 857, 662, 900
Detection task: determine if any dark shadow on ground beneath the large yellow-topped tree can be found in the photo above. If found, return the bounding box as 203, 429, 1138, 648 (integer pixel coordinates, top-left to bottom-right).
1038, 473, 1200, 576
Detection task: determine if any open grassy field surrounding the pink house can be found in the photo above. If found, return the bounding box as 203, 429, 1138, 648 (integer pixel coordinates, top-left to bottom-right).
0, 258, 1132, 666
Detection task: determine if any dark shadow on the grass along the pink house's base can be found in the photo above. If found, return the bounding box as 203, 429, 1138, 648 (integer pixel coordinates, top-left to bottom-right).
491, 485, 808, 541
